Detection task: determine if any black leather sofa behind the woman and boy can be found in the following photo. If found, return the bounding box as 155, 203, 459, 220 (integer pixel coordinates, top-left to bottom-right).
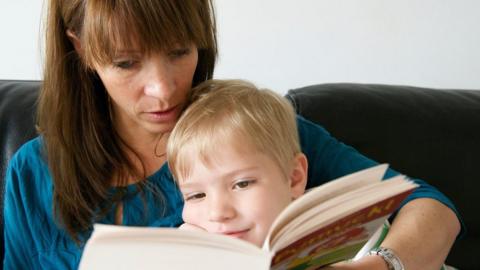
0, 80, 480, 269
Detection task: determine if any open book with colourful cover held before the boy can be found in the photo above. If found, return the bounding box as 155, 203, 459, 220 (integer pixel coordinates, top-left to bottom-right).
80, 164, 417, 270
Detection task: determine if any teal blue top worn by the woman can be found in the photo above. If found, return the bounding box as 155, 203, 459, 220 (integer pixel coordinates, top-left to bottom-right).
4, 117, 463, 269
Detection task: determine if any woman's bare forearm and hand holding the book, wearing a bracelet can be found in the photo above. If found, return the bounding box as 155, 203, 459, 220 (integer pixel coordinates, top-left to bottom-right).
325, 198, 460, 270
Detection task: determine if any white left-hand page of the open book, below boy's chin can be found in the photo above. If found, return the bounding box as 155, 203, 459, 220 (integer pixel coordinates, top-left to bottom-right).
79, 224, 272, 270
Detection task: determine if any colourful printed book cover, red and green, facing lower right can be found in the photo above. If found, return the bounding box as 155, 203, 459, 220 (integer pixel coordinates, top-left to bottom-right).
272, 191, 414, 270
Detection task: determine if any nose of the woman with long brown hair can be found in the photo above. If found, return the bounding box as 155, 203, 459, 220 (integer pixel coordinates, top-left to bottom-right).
145, 59, 175, 99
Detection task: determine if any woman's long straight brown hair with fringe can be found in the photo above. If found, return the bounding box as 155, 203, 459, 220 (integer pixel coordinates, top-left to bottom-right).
37, 0, 217, 242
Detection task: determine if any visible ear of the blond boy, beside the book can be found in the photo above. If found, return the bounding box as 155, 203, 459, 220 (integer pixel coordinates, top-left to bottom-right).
289, 153, 308, 200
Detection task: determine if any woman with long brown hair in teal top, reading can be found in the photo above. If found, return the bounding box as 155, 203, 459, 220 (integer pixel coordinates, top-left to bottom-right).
4, 0, 460, 269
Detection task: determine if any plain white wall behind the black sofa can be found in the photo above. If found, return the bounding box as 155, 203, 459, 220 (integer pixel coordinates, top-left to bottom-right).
0, 0, 480, 93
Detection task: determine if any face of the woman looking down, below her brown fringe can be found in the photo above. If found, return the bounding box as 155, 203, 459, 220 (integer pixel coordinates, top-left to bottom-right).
96, 44, 198, 138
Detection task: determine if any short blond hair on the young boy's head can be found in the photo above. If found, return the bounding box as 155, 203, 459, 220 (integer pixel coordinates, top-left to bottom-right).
167, 80, 300, 181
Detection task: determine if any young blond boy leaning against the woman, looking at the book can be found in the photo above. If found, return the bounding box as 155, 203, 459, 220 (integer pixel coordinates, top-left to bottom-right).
167, 80, 307, 246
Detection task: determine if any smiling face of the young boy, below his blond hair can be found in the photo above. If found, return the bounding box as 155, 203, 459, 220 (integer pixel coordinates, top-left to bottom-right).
178, 146, 306, 246
